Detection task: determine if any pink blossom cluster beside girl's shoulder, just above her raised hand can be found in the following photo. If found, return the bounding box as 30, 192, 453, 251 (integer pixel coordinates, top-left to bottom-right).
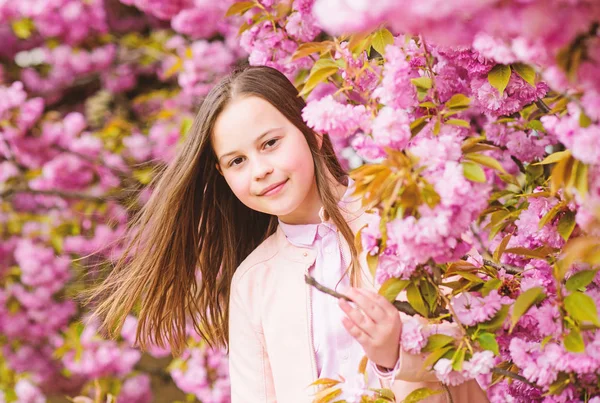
377, 128, 491, 282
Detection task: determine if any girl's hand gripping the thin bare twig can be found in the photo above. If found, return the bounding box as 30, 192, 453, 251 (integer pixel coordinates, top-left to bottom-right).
339, 288, 402, 368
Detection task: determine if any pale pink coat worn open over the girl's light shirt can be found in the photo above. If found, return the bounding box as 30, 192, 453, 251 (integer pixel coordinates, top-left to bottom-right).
229, 195, 488, 403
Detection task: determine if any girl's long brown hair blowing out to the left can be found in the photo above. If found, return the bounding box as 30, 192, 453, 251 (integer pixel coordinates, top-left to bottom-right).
85, 67, 359, 355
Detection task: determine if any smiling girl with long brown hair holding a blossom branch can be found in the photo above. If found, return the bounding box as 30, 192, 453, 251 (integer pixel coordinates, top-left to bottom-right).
92, 67, 486, 403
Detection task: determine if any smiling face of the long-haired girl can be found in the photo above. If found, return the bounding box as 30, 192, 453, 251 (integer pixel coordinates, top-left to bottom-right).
212, 96, 320, 223
